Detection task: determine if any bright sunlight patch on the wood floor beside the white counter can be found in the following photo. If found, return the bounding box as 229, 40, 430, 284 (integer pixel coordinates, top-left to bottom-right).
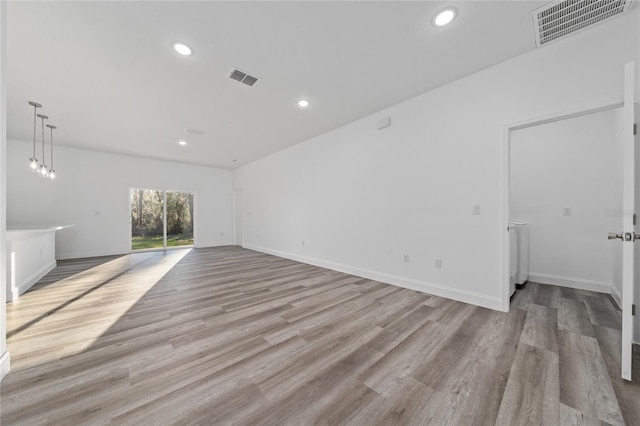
7, 249, 192, 370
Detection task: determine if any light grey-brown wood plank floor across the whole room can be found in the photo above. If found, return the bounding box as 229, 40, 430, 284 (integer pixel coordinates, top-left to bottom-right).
0, 247, 640, 426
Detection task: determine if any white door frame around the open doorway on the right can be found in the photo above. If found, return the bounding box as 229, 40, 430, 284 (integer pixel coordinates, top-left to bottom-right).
500, 99, 624, 312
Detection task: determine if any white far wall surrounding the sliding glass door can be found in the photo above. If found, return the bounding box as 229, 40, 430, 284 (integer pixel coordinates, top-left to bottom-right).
7, 141, 233, 259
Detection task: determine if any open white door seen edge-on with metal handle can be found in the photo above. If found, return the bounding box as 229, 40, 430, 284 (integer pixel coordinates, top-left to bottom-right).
610, 62, 640, 380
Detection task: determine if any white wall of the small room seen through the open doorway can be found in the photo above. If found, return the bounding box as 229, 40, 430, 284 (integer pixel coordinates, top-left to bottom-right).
510, 109, 623, 301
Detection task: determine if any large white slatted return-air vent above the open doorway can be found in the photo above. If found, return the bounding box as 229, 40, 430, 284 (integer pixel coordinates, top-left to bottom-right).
531, 0, 633, 47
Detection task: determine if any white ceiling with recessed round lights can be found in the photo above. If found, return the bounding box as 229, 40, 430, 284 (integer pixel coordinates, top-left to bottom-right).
7, 1, 548, 169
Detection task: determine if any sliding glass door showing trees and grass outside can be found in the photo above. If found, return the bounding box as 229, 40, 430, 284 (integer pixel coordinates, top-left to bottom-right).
130, 188, 194, 250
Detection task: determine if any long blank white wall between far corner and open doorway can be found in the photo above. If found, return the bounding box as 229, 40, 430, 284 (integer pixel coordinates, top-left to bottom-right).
234, 10, 638, 309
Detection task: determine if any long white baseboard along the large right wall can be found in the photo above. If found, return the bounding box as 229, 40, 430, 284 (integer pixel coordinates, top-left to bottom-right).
243, 244, 502, 310
